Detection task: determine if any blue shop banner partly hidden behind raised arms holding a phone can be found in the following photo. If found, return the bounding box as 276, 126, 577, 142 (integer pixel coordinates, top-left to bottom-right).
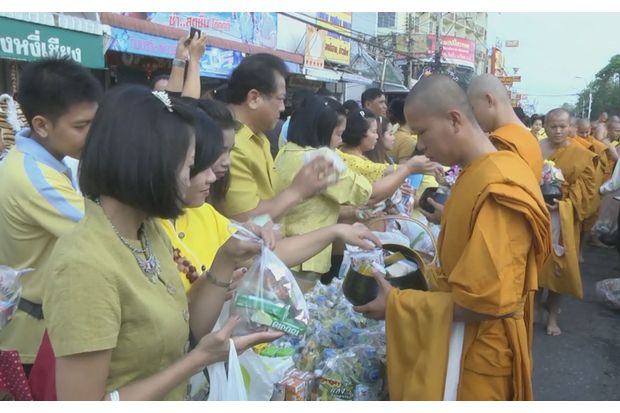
110, 27, 244, 79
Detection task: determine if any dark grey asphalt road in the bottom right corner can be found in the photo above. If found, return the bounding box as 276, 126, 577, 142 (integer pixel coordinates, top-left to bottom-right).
534, 246, 620, 400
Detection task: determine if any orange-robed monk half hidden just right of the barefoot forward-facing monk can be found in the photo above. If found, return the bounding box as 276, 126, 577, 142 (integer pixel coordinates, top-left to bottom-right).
573, 119, 613, 256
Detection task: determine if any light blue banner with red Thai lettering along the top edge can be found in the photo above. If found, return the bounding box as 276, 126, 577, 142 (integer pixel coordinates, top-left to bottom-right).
121, 12, 278, 49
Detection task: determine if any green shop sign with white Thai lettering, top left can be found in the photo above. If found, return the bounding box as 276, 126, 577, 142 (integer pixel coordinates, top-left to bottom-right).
0, 17, 104, 69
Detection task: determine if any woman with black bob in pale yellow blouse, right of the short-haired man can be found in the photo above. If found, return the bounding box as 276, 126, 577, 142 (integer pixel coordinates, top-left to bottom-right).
275, 97, 438, 291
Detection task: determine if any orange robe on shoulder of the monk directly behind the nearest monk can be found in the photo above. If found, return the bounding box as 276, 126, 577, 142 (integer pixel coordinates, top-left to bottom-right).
489, 123, 543, 181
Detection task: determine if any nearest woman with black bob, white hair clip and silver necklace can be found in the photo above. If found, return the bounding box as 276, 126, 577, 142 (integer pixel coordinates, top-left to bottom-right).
43, 86, 281, 400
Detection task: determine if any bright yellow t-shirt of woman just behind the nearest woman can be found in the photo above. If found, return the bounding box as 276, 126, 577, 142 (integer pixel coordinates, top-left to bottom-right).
160, 203, 233, 291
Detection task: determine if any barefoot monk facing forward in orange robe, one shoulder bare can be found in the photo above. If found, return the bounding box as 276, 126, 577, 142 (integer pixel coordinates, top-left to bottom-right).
539, 109, 599, 336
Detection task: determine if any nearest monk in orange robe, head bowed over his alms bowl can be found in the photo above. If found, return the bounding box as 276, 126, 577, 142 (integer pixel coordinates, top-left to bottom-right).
355, 75, 550, 400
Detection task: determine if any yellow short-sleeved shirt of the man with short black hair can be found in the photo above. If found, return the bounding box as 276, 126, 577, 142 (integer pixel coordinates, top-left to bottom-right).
225, 124, 275, 217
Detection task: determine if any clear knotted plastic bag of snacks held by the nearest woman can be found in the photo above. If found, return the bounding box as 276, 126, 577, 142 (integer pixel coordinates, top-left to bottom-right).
231, 225, 309, 337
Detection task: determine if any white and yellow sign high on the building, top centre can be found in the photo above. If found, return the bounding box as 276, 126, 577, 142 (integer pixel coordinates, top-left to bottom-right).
316, 12, 351, 65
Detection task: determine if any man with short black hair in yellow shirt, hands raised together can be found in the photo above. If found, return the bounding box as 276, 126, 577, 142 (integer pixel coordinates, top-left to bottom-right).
224, 53, 331, 221
